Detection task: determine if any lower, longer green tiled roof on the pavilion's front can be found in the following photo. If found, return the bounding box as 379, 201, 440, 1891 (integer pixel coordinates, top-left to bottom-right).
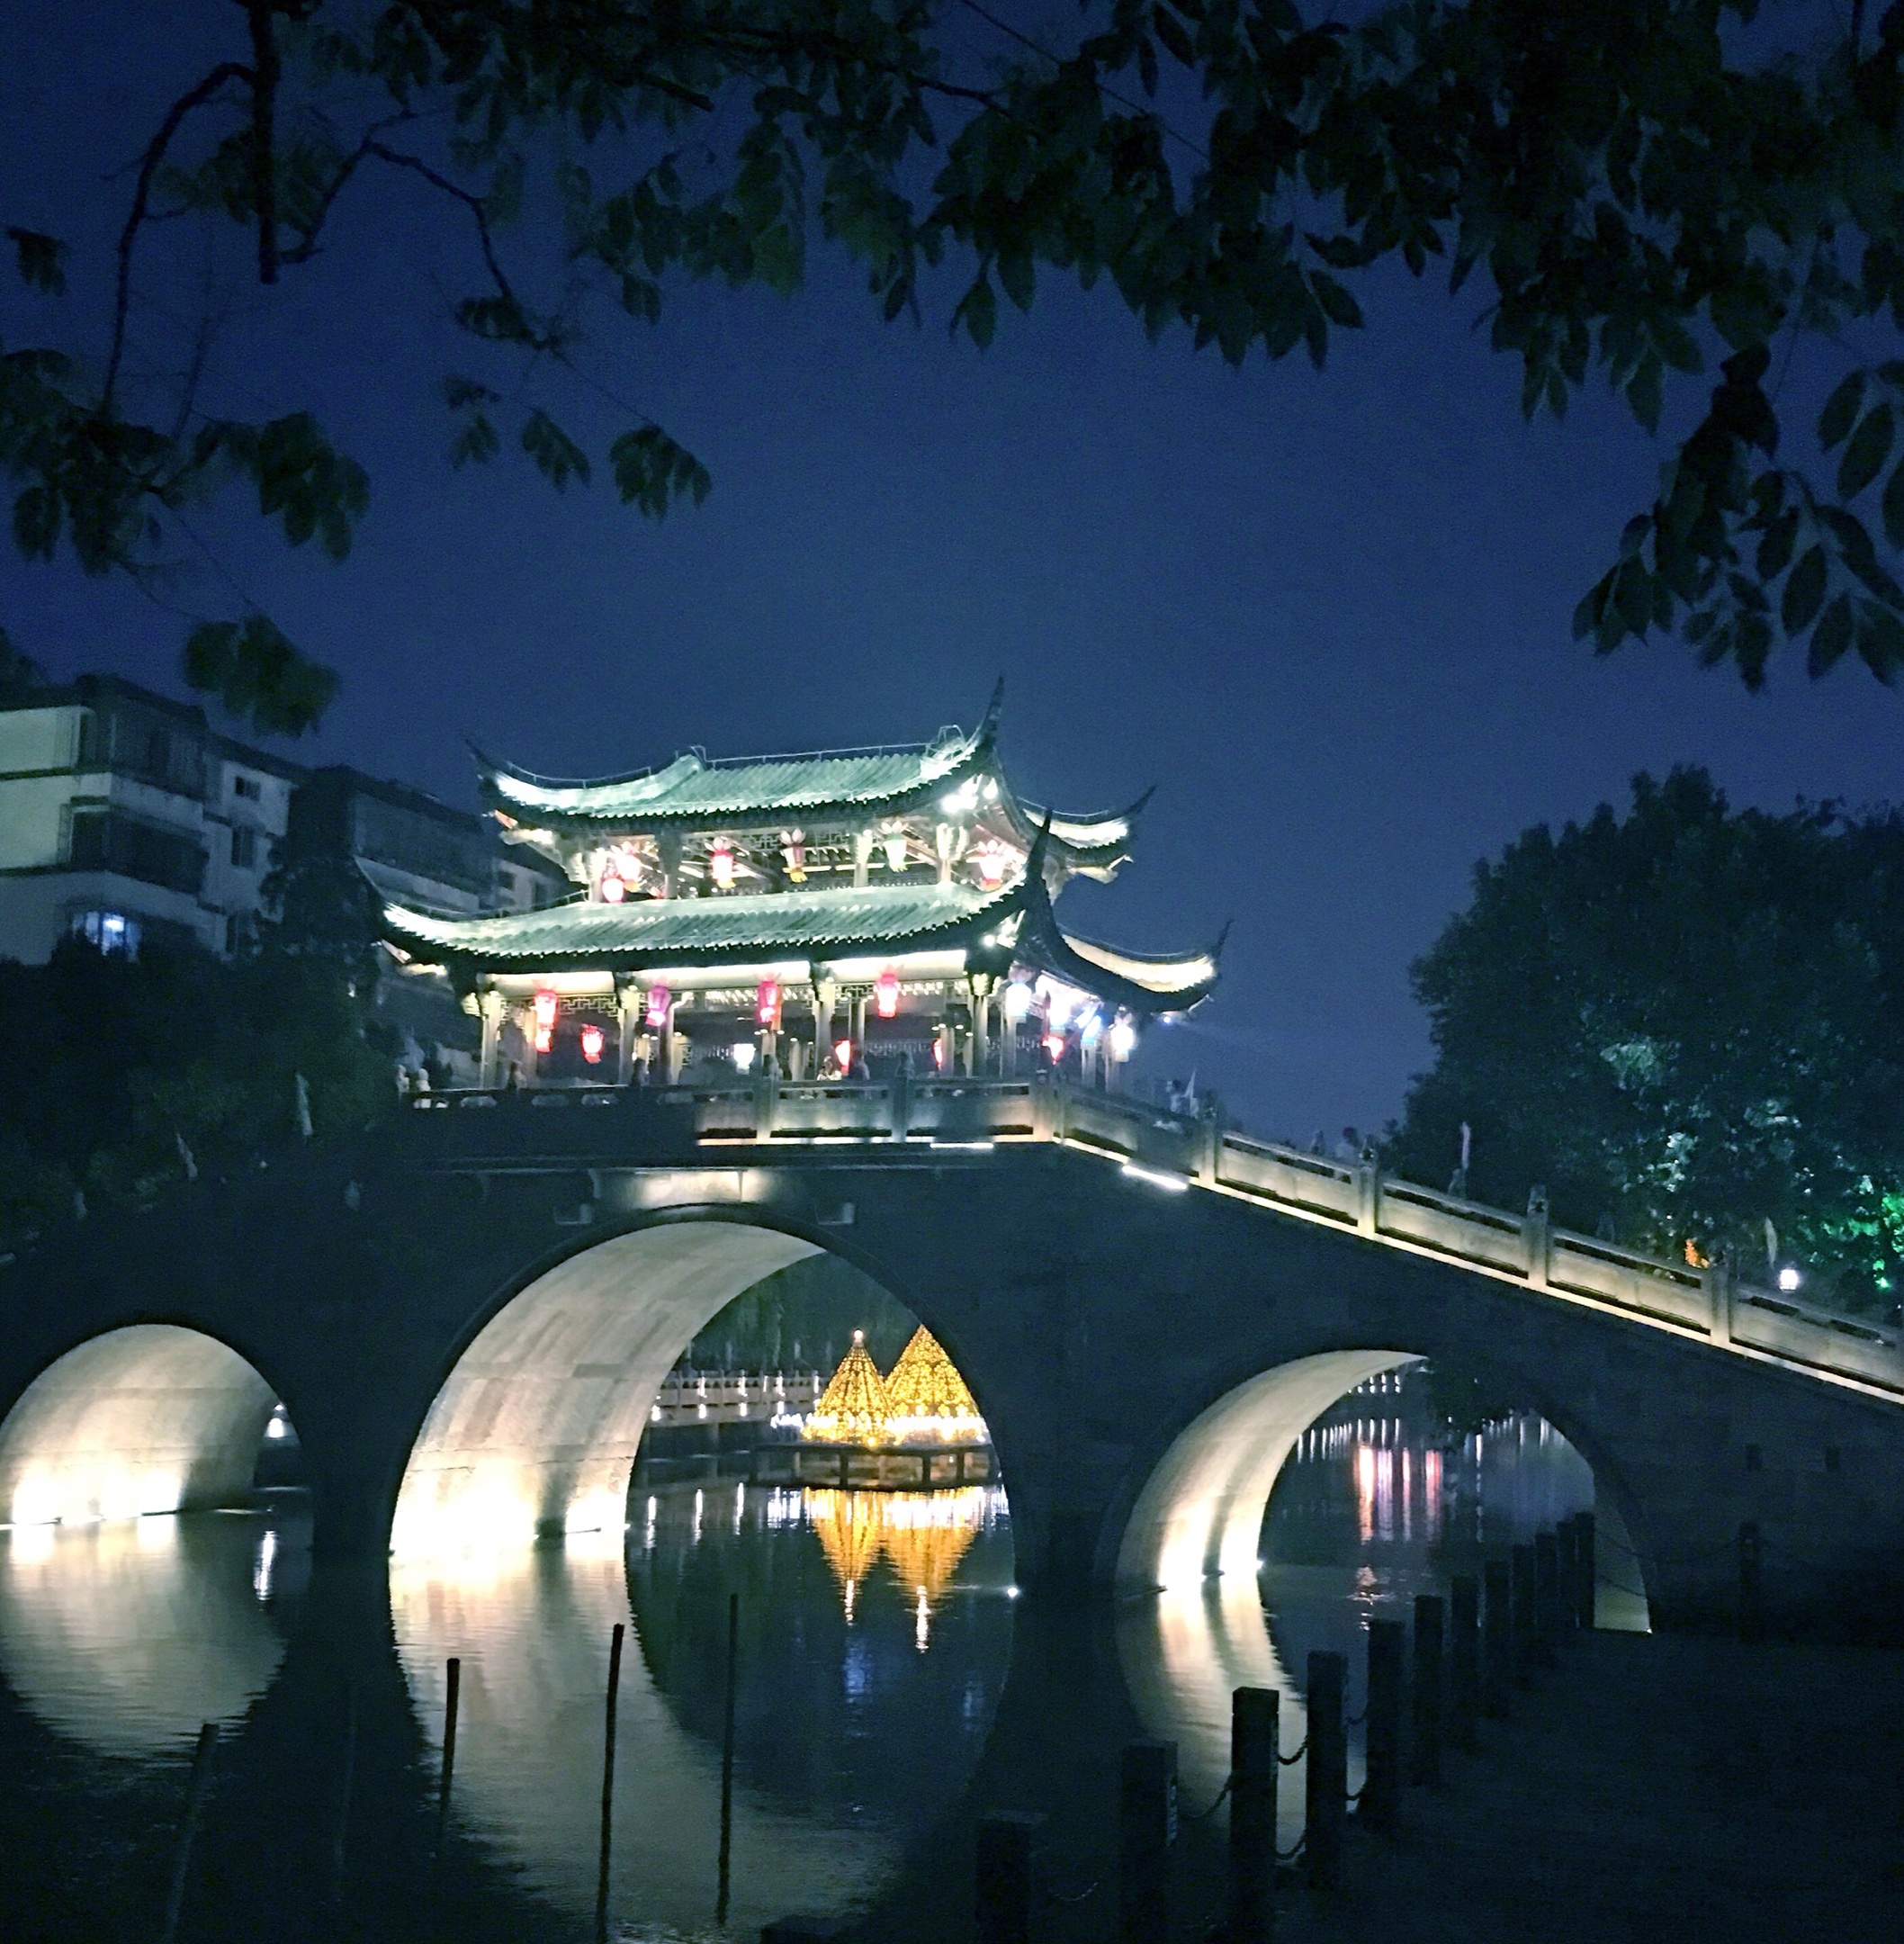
382, 885, 1022, 968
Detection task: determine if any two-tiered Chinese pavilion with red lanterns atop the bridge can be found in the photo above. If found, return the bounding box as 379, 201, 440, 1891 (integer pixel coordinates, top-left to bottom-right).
382, 694, 1217, 1086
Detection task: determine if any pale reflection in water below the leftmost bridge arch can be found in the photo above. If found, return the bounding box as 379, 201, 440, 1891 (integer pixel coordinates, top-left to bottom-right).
0, 1512, 309, 1755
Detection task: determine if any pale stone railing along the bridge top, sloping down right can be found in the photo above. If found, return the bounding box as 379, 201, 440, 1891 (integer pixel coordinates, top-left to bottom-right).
401, 1075, 1904, 1396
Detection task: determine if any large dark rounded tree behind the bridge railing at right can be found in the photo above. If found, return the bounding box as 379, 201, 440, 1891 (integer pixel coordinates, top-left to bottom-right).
1388, 768, 1904, 1309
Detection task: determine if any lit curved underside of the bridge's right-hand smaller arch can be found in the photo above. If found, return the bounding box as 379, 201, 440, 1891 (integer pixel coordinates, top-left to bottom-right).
1115, 1349, 1420, 1592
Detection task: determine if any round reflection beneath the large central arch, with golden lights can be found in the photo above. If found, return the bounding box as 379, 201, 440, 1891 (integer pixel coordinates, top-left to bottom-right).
391, 1483, 1010, 1936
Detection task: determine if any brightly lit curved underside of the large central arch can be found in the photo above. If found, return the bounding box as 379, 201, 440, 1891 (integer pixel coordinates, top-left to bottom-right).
391, 1223, 818, 1557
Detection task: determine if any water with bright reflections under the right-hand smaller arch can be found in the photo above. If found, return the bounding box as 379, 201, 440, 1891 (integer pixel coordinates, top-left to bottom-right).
1118, 1381, 1616, 1847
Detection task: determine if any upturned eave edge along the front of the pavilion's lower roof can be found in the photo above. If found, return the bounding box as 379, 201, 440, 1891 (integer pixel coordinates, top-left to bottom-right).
381, 885, 1024, 976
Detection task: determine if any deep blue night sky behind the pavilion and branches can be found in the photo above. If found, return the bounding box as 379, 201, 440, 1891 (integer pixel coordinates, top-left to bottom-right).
0, 0, 1904, 1139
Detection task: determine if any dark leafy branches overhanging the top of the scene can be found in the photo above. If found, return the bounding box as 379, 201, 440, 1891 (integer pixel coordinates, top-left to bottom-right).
11, 0, 1904, 733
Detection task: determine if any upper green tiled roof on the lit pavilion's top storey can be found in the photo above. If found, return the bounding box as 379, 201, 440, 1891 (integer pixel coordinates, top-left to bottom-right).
484, 739, 979, 826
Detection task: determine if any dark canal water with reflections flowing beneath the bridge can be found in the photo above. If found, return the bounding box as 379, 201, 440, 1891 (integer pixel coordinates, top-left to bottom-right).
0, 1394, 1594, 1944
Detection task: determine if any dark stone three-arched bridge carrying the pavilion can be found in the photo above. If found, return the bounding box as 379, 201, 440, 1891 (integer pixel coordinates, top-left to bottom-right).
0, 1079, 1904, 1625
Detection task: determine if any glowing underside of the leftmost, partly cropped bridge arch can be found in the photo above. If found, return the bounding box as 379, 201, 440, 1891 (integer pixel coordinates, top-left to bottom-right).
0, 1324, 274, 1526
